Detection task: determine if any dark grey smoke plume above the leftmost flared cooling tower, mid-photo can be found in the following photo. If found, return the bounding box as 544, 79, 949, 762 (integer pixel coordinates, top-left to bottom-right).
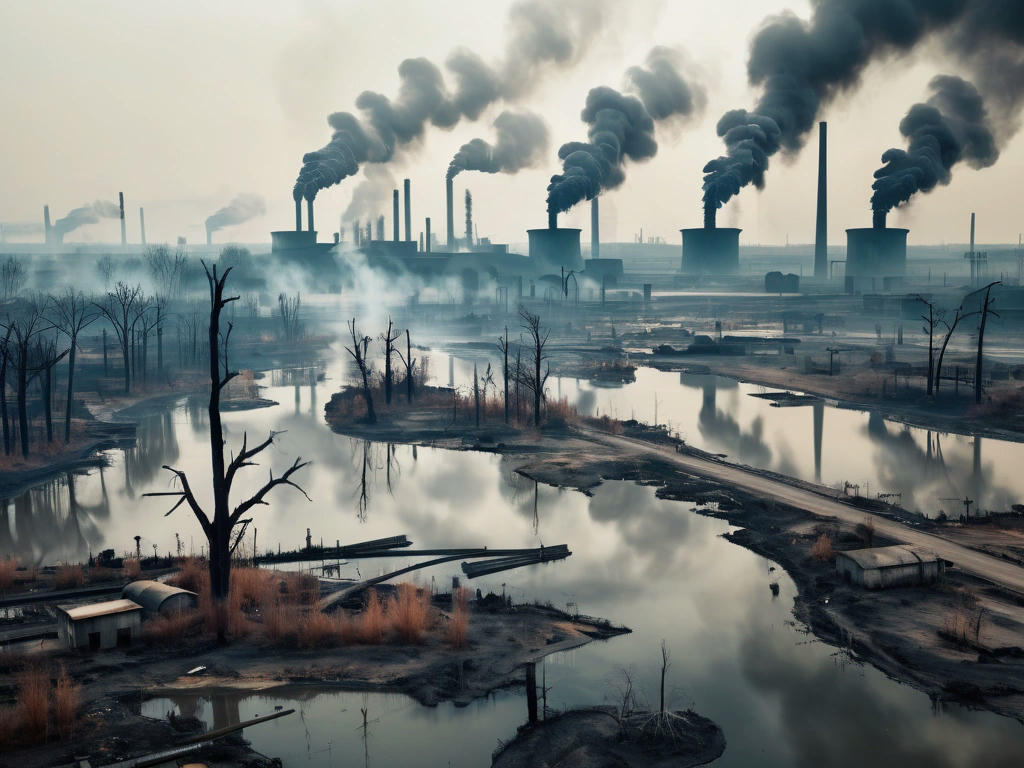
548, 48, 705, 213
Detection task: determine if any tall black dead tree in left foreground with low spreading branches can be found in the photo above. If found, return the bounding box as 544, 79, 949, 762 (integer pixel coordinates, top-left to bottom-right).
145, 263, 309, 630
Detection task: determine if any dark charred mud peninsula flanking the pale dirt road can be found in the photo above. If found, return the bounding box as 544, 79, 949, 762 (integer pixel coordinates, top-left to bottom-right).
326, 390, 1024, 718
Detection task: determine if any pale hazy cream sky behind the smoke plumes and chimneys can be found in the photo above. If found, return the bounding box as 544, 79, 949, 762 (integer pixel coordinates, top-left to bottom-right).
0, 0, 1024, 244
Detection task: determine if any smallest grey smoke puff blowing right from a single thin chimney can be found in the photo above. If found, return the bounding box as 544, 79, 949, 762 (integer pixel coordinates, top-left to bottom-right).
447, 111, 548, 178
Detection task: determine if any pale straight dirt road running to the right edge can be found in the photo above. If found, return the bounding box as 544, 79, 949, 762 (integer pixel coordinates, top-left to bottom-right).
584, 429, 1024, 595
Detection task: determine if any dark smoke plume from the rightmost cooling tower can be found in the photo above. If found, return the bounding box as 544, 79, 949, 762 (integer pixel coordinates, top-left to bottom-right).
871, 75, 999, 213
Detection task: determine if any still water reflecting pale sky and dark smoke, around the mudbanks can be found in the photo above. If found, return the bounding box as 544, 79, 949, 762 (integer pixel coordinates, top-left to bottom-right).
0, 352, 1024, 767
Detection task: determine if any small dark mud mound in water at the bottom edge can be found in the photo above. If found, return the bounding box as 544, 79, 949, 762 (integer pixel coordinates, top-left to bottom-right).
492, 707, 725, 768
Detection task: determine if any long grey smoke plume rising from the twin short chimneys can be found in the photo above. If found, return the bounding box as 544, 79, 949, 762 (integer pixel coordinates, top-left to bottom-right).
292, 0, 607, 201
